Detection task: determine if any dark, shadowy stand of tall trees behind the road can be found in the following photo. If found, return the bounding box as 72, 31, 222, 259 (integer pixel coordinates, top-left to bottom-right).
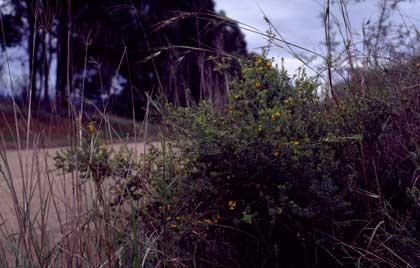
0, 0, 246, 116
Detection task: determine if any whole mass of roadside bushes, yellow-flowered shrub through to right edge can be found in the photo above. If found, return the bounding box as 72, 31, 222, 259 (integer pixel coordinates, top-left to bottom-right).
57, 55, 420, 267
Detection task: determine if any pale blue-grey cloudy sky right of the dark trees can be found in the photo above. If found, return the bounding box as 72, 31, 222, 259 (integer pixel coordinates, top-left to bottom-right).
216, 0, 420, 73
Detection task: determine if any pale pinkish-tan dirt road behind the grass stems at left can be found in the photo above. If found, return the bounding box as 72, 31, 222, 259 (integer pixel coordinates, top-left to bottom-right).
0, 143, 153, 235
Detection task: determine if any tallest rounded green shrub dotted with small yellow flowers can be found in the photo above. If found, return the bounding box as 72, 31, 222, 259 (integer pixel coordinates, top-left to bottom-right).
158, 56, 368, 267
